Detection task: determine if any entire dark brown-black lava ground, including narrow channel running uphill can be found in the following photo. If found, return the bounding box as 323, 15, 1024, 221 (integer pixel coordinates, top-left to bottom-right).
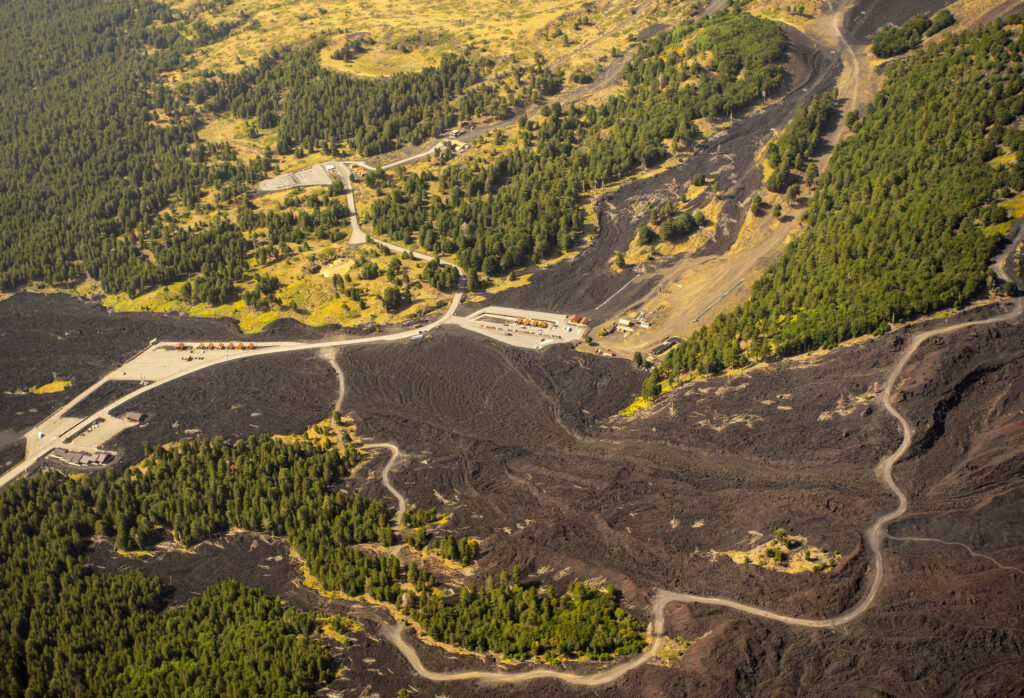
0, 0, 1024, 697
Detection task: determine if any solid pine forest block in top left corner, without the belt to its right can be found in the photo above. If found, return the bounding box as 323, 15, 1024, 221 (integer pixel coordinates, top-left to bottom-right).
0, 0, 265, 292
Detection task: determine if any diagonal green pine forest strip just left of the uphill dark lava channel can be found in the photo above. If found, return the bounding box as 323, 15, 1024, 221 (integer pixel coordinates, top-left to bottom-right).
372, 11, 787, 278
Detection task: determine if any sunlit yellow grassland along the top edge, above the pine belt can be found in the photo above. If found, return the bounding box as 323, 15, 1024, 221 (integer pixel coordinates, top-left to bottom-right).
172, 0, 695, 77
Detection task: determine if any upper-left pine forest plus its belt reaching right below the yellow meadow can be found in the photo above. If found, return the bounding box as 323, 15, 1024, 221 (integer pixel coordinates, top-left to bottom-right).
0, 0, 562, 296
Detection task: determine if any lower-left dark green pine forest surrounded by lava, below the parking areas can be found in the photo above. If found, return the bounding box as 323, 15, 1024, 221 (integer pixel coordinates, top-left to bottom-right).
0, 429, 645, 695
